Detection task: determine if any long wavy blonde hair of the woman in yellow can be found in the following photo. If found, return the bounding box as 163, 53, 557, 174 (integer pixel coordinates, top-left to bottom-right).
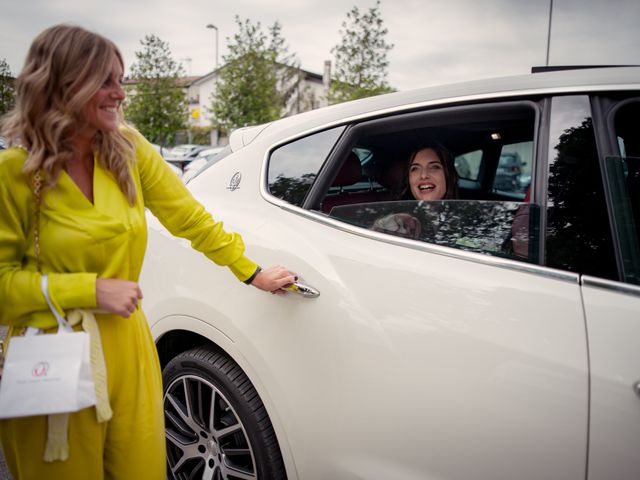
0, 25, 136, 205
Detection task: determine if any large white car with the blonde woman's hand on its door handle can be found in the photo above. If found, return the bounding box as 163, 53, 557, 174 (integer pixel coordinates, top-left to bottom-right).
141, 68, 640, 480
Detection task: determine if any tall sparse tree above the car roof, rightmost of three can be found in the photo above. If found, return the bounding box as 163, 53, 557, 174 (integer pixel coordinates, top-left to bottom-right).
329, 0, 393, 103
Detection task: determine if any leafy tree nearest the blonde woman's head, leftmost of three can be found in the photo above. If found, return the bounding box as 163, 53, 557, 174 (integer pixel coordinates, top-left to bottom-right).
126, 35, 188, 145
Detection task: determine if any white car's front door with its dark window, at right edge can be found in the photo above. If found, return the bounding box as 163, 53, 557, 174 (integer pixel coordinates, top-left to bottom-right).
582, 97, 640, 480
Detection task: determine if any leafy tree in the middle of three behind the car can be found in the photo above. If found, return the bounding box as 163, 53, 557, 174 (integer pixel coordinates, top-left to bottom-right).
210, 16, 301, 132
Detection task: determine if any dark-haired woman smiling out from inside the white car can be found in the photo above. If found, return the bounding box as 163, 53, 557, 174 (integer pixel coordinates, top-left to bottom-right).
372, 143, 458, 238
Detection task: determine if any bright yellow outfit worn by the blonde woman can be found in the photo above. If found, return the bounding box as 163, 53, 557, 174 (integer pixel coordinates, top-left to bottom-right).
0, 132, 257, 480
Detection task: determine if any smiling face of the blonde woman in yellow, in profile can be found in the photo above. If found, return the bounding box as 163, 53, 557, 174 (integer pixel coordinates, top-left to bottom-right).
82, 55, 125, 137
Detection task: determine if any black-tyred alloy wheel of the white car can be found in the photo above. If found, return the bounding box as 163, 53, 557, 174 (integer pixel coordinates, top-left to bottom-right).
162, 347, 286, 480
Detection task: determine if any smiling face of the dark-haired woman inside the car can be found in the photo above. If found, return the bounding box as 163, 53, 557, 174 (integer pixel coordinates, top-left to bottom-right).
409, 148, 447, 200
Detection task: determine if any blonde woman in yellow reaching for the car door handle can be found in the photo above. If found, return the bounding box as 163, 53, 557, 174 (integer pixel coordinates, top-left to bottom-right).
0, 25, 295, 480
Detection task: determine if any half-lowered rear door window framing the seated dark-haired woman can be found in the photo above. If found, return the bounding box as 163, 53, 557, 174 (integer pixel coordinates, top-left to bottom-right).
319, 102, 540, 263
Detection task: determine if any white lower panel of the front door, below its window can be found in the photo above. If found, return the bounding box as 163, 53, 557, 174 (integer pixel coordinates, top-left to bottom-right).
583, 279, 640, 480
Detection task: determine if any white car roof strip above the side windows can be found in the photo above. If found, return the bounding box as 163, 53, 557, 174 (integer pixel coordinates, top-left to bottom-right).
242, 66, 640, 150
